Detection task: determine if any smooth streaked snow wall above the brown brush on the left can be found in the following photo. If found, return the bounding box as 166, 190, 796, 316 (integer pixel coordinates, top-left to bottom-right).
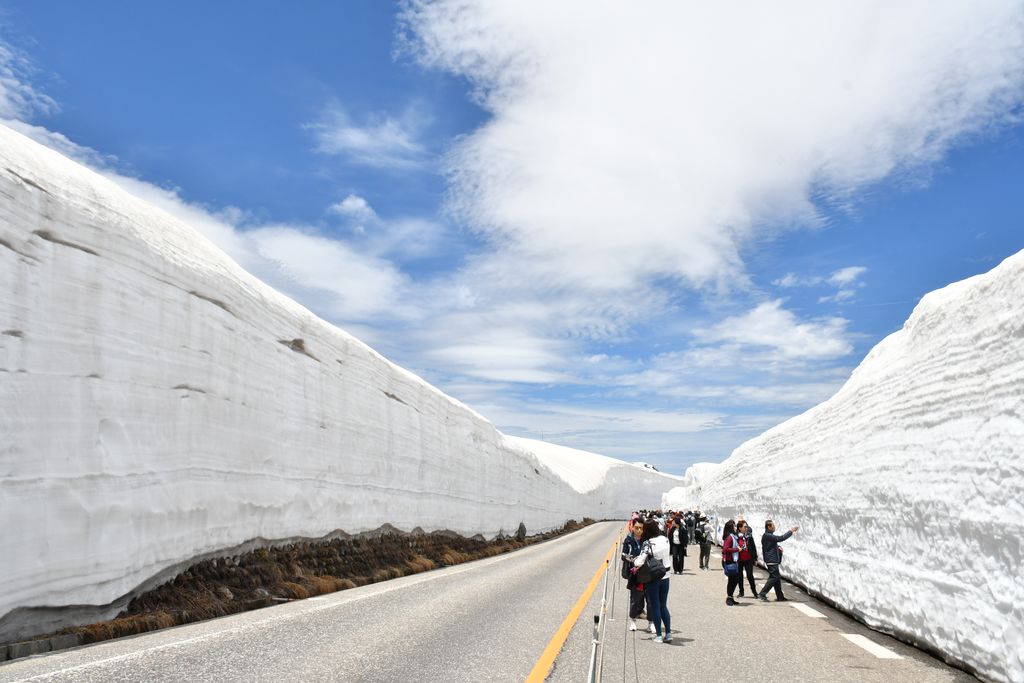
0, 126, 679, 642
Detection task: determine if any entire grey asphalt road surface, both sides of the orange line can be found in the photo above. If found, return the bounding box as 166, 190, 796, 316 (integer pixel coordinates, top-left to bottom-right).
0, 522, 976, 683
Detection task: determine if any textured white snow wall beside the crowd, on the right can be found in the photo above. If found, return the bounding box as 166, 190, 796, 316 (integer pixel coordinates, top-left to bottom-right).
700, 252, 1024, 682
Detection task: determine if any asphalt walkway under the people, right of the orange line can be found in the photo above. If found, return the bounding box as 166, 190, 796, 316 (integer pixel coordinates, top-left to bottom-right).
548, 546, 977, 683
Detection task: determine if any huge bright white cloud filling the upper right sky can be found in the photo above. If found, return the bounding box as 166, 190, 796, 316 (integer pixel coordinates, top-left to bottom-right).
404, 0, 1024, 291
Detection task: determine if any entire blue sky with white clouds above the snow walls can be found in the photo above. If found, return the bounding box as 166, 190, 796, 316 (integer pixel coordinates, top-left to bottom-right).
0, 0, 1024, 472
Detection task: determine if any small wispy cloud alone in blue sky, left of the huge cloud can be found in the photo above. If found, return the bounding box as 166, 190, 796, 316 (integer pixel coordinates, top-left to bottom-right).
306, 103, 428, 169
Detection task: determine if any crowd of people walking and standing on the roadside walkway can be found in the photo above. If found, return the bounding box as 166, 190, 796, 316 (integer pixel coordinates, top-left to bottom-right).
622, 510, 800, 643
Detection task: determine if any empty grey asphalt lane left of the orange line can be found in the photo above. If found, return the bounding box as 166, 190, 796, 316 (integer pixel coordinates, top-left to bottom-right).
0, 522, 623, 683
